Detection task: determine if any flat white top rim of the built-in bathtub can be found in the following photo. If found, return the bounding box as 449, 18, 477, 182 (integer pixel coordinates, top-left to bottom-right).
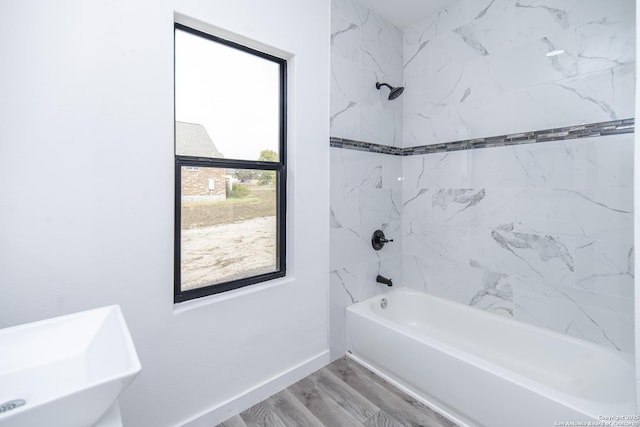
347, 286, 635, 420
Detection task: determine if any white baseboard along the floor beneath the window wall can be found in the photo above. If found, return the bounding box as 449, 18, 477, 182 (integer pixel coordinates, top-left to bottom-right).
178, 351, 329, 427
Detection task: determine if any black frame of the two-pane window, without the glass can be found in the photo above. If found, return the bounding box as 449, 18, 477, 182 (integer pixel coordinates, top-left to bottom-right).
173, 22, 287, 303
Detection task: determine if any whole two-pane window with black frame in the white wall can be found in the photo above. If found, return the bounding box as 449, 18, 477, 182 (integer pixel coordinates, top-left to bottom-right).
174, 24, 287, 302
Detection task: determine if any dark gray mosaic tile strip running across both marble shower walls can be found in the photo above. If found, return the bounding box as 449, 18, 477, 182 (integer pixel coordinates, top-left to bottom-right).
329, 118, 635, 156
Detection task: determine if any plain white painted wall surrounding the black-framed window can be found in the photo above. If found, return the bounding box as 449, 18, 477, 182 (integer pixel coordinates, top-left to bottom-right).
0, 0, 330, 427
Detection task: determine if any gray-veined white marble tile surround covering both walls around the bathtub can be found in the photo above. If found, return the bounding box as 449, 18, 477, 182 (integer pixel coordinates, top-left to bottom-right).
331, 0, 635, 358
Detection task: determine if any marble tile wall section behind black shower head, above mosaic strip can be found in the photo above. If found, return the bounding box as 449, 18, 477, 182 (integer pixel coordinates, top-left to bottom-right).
330, 0, 403, 147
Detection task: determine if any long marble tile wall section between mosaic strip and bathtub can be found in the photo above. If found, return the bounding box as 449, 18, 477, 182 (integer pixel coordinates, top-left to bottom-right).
402, 134, 634, 352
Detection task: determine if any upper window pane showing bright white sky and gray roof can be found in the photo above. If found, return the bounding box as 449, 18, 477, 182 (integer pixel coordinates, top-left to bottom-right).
175, 29, 281, 161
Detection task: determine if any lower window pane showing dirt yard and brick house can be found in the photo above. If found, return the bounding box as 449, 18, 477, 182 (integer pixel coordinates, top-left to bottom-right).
180, 166, 278, 291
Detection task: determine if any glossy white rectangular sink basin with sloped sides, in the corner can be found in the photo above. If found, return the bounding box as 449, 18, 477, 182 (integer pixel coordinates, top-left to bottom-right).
0, 305, 141, 427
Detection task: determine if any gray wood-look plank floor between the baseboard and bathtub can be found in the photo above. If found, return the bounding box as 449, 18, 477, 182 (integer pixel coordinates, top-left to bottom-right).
218, 357, 456, 427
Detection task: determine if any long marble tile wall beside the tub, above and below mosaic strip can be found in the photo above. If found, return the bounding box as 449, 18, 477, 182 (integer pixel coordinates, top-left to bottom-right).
402, 0, 635, 352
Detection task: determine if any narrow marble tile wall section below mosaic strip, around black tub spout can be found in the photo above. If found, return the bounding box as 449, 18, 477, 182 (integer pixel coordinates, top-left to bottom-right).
329, 148, 403, 359
